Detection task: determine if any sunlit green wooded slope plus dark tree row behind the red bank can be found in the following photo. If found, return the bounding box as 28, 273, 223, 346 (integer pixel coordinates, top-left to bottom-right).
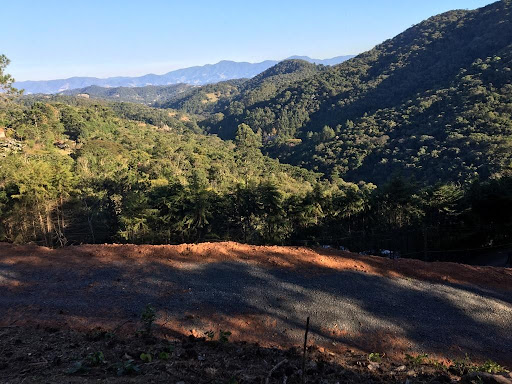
0, 90, 512, 259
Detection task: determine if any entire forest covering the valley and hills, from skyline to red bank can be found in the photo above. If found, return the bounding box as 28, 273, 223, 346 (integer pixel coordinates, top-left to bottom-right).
0, 1, 512, 260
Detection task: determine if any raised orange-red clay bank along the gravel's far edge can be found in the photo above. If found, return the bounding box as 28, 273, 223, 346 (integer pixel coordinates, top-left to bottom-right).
0, 242, 512, 292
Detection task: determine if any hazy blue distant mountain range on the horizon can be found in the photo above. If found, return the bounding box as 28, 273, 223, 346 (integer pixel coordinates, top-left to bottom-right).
14, 55, 354, 94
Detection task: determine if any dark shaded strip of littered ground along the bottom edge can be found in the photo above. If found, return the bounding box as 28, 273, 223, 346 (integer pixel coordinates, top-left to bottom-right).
0, 327, 460, 384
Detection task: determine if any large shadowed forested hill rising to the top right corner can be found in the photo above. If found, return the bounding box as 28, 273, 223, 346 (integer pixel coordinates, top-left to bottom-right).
199, 0, 512, 182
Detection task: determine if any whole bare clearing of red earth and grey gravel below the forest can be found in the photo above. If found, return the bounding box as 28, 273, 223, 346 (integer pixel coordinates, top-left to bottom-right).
0, 242, 512, 367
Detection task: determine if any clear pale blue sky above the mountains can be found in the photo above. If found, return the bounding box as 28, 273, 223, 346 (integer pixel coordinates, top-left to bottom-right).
0, 0, 493, 81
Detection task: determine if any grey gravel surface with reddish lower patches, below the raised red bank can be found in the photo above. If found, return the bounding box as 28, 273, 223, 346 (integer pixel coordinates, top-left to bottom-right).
0, 243, 512, 366
